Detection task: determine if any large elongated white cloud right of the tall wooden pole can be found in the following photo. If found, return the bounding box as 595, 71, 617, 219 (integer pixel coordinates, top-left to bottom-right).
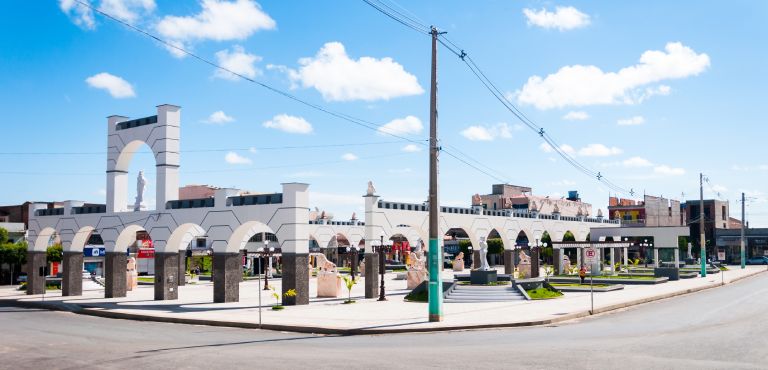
512, 42, 710, 110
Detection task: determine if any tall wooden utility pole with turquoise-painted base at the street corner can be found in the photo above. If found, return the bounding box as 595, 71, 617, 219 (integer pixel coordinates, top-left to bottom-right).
428, 27, 443, 322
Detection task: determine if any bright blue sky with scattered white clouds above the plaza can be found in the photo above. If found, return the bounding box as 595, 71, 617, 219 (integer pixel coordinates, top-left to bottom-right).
0, 0, 768, 226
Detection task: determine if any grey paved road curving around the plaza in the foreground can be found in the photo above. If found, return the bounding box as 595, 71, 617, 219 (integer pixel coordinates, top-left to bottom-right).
0, 274, 768, 369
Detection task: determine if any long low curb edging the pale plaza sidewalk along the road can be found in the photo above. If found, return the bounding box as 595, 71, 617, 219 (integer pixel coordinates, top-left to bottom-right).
0, 270, 768, 336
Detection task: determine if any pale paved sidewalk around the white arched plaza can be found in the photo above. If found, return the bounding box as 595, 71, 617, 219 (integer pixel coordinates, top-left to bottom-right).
0, 266, 766, 335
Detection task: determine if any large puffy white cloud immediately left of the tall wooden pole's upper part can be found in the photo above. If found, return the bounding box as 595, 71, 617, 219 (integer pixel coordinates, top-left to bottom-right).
284, 42, 424, 101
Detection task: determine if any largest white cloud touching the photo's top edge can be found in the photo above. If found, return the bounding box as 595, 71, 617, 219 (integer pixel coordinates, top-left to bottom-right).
157, 0, 276, 56
